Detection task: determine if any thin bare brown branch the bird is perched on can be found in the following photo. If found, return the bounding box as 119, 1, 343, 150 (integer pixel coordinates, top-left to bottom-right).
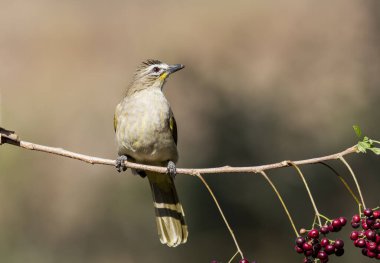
0, 127, 358, 176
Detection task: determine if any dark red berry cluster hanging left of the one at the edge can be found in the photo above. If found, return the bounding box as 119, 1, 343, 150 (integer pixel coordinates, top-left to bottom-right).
294, 217, 347, 263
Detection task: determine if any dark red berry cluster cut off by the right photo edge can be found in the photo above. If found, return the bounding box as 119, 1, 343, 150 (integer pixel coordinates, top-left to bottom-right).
350, 208, 380, 259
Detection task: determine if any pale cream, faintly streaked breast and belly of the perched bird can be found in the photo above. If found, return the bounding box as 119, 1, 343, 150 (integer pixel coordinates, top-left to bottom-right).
116, 90, 178, 162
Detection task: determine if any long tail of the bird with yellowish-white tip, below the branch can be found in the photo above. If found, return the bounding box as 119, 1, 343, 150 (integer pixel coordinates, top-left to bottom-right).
147, 172, 188, 247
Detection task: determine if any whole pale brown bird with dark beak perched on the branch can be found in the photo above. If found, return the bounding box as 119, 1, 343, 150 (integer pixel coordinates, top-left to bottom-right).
114, 59, 188, 247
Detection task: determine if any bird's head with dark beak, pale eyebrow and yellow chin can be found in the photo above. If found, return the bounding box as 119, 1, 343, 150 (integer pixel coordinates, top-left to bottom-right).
129, 59, 185, 92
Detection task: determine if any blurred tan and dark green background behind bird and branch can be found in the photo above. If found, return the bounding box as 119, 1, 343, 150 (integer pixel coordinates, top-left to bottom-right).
0, 0, 380, 263
